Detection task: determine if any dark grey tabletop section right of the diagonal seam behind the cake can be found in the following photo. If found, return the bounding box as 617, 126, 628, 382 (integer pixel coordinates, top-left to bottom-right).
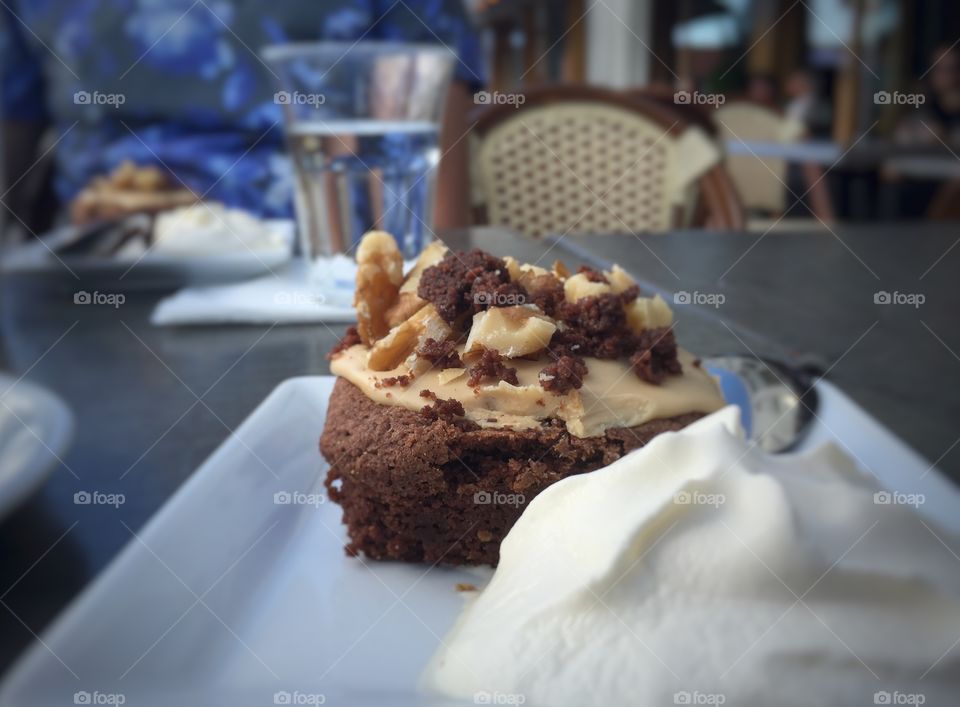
562, 223, 960, 480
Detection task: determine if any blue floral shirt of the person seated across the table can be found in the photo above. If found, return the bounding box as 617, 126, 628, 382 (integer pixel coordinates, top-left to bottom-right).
0, 0, 482, 216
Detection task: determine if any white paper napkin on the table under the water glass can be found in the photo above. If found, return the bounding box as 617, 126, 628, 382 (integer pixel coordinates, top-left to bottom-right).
150, 255, 357, 326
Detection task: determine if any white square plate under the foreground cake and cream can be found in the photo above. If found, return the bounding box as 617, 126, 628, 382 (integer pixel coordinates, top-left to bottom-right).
0, 377, 960, 706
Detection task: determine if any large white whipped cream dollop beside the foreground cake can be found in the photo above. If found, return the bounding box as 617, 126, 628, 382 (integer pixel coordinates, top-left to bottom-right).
422, 407, 960, 706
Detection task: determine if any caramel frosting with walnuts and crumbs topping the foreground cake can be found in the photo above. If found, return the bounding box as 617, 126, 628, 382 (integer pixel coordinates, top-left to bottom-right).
330, 232, 724, 437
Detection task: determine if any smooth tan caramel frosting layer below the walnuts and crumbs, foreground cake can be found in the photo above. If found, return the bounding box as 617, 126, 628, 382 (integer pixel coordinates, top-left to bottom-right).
330, 344, 724, 437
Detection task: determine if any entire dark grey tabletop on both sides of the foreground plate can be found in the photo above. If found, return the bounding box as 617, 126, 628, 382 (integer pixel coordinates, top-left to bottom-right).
0, 226, 960, 672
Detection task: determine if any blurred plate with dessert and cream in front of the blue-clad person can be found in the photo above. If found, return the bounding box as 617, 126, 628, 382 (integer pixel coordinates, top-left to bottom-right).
2, 162, 295, 289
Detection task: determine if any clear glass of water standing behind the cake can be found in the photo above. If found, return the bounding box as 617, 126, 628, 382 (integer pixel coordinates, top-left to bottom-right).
262, 42, 455, 259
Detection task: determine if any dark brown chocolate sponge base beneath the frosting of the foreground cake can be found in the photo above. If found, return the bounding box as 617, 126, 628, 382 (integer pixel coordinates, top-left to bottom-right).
320, 378, 703, 565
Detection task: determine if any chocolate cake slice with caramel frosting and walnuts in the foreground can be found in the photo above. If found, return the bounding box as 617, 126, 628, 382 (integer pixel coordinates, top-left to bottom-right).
320, 232, 723, 565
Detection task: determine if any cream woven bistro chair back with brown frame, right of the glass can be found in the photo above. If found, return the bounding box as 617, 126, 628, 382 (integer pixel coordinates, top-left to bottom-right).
471, 86, 744, 237
